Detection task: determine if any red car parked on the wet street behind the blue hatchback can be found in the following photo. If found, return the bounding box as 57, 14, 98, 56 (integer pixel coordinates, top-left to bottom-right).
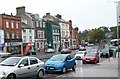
82, 53, 100, 64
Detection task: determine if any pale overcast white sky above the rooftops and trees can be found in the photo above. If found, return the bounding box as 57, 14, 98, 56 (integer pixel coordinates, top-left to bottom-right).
0, 0, 118, 31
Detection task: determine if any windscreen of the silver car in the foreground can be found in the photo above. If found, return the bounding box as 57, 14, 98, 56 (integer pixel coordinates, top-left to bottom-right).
0, 57, 21, 66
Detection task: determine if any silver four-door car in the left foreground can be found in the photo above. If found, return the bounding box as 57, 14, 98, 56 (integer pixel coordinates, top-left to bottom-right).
0, 56, 44, 79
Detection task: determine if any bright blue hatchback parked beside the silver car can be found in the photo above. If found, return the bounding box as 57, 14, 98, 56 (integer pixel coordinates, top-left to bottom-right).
45, 54, 76, 73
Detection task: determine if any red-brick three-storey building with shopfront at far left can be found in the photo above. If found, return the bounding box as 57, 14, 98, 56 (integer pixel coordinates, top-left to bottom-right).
0, 13, 23, 54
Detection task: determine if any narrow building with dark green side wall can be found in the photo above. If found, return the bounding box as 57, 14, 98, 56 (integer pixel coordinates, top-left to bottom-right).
43, 13, 61, 50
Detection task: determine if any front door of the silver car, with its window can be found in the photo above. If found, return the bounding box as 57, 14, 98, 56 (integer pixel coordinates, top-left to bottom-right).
16, 58, 30, 77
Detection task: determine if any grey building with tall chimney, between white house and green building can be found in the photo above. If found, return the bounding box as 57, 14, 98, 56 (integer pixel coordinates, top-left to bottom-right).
16, 6, 47, 50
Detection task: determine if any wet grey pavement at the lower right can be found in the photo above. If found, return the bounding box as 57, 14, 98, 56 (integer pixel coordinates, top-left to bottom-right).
59, 57, 119, 79
